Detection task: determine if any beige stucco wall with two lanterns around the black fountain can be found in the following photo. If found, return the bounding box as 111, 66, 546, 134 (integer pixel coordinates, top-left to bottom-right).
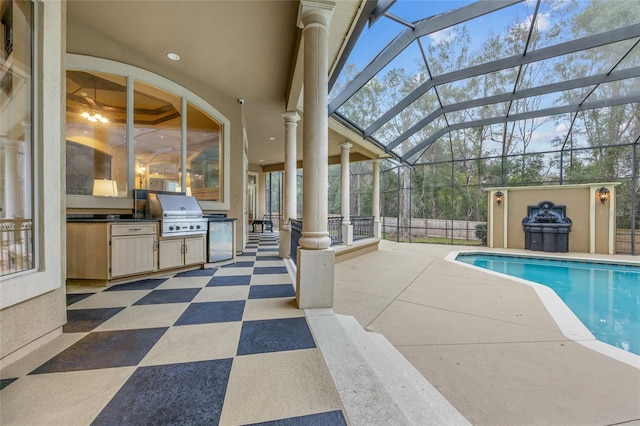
487, 183, 618, 254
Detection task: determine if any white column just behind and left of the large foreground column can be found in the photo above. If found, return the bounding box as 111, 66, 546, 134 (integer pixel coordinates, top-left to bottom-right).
279, 111, 300, 258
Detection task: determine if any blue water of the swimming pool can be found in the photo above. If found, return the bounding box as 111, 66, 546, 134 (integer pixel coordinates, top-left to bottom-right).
456, 253, 640, 355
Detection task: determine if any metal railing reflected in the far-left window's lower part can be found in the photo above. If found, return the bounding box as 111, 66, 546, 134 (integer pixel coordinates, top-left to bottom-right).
0, 219, 33, 275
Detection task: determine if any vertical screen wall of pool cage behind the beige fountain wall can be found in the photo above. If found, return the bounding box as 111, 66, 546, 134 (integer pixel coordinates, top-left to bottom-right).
380, 145, 640, 255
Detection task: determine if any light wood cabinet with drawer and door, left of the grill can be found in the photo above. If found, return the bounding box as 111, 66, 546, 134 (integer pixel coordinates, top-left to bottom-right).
67, 222, 158, 283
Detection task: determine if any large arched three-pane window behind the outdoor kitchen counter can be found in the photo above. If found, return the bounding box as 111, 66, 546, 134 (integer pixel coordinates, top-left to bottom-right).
66, 54, 230, 210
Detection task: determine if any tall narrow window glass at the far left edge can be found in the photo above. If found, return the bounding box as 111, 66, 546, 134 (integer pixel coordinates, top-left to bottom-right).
0, 0, 35, 276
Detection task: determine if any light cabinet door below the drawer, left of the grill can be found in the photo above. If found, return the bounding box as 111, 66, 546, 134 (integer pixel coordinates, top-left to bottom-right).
111, 235, 156, 278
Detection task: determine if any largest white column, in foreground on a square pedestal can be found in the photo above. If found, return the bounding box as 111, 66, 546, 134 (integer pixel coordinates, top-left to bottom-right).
296, 0, 335, 309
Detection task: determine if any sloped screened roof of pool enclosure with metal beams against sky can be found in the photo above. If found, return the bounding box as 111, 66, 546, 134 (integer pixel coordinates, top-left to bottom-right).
329, 0, 640, 165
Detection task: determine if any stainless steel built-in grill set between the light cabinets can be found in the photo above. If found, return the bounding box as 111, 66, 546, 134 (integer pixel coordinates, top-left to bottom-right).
149, 193, 208, 237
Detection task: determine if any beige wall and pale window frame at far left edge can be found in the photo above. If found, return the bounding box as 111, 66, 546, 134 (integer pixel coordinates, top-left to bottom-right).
0, 0, 66, 367
